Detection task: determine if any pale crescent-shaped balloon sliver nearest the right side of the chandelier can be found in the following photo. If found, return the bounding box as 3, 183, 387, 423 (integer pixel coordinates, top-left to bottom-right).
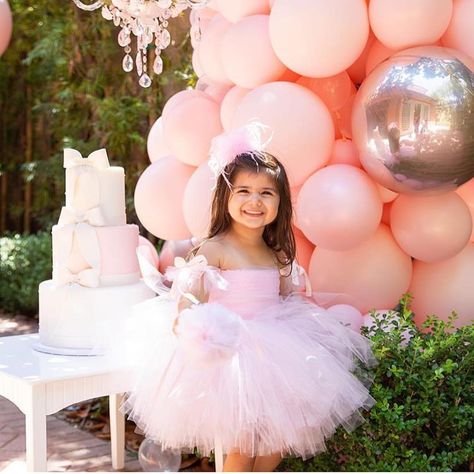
199, 15, 232, 85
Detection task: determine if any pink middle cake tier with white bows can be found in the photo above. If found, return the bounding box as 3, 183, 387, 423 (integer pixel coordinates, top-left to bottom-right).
52, 223, 140, 287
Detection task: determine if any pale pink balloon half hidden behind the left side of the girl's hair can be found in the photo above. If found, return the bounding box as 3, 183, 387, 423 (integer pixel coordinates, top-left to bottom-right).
183, 162, 215, 238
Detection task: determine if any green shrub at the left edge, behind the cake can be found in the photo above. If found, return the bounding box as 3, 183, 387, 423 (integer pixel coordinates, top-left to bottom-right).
0, 232, 52, 315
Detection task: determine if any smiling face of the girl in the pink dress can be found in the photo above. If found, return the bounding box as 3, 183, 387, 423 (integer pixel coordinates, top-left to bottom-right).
228, 171, 280, 229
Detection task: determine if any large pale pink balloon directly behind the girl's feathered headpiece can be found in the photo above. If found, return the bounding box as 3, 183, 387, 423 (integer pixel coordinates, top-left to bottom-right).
232, 82, 334, 187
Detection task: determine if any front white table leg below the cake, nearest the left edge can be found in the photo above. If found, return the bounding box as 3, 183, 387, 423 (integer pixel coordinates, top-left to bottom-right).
25, 385, 47, 472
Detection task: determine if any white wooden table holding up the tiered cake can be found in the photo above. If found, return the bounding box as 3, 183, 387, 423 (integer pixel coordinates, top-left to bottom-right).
0, 334, 130, 471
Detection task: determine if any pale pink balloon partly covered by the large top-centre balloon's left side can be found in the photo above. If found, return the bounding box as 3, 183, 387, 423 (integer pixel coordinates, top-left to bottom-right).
221, 15, 286, 89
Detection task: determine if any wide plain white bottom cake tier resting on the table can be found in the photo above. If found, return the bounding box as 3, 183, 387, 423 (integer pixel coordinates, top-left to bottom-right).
39, 280, 155, 353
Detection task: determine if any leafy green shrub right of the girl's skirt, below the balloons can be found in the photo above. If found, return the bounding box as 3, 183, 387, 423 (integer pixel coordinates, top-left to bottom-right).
280, 296, 474, 472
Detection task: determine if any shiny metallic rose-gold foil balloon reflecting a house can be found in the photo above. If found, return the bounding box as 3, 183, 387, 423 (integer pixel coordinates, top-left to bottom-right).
352, 46, 474, 194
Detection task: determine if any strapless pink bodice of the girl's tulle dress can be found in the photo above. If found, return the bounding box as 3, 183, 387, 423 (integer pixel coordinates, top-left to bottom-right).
209, 268, 280, 319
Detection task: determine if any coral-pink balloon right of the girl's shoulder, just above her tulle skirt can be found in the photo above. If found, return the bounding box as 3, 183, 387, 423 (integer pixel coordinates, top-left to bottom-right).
309, 224, 412, 313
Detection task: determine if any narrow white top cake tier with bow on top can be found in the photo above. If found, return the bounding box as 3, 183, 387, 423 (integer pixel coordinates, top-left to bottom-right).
60, 148, 126, 226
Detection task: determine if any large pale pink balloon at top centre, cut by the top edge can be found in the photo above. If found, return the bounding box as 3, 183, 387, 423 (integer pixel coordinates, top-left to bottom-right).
270, 0, 369, 77
